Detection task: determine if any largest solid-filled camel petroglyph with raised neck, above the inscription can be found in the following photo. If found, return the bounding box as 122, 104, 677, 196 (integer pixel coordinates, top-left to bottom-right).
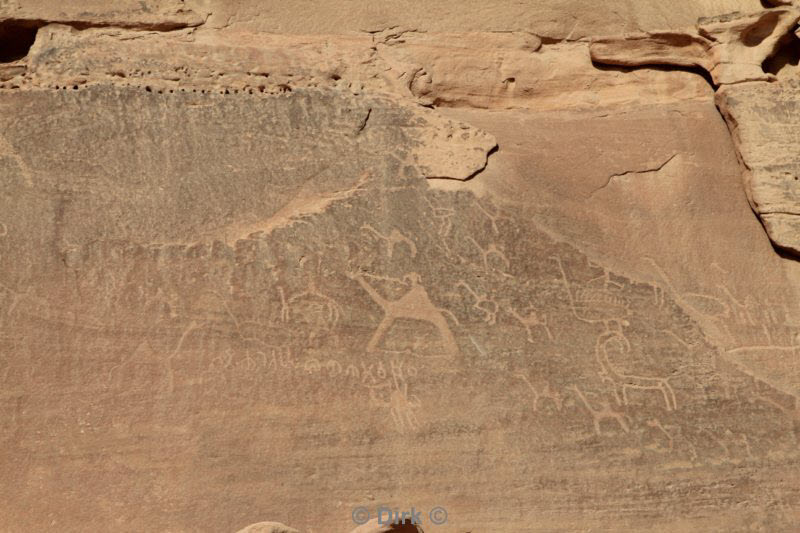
353, 272, 458, 356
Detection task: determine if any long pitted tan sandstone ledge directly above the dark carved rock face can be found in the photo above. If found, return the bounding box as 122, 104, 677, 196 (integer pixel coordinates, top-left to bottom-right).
17, 25, 705, 109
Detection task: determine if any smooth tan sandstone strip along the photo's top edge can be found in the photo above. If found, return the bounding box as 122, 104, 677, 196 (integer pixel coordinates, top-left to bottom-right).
187, 0, 762, 41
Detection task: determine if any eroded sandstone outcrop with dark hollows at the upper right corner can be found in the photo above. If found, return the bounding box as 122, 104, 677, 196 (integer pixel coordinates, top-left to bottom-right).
590, 9, 800, 254
